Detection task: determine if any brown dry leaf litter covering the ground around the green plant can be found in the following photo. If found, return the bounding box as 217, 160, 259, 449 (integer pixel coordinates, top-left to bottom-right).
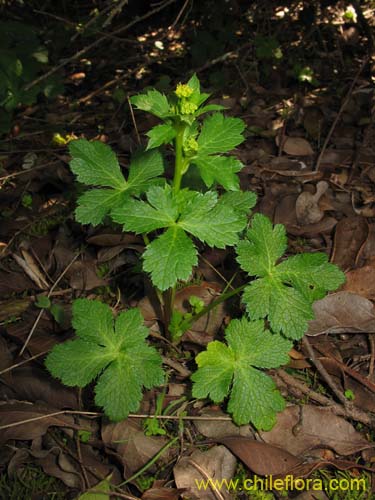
0, 2, 375, 499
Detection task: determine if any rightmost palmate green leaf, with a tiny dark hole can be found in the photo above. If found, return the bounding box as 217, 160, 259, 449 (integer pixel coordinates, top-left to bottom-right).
237, 214, 345, 340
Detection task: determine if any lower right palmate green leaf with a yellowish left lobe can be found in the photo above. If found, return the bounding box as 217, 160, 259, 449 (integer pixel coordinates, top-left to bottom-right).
191, 318, 292, 430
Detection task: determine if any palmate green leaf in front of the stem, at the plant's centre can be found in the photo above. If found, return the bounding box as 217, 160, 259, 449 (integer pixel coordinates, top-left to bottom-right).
111, 185, 247, 290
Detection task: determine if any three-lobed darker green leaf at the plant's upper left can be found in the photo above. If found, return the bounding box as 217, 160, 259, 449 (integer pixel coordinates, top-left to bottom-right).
69, 139, 164, 225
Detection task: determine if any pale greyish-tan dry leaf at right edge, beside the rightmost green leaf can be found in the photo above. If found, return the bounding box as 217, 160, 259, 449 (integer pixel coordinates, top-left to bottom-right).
306, 292, 375, 336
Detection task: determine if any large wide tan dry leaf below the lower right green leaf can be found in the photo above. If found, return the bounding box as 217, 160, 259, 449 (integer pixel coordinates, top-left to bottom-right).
260, 405, 374, 456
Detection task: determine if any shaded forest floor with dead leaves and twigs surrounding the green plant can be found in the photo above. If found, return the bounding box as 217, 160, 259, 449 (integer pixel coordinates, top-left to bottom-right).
0, 1, 375, 500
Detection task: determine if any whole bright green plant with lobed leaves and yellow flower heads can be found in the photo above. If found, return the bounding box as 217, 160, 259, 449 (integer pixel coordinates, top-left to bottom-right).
46, 75, 344, 429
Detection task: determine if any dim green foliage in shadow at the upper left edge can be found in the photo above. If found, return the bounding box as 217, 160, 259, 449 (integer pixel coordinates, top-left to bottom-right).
0, 21, 63, 133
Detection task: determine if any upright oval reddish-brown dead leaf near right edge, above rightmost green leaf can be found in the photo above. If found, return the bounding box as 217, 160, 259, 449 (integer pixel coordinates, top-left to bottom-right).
331, 215, 369, 271
